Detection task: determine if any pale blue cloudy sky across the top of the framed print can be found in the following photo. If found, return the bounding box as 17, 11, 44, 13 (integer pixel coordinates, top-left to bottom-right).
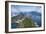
11, 5, 41, 15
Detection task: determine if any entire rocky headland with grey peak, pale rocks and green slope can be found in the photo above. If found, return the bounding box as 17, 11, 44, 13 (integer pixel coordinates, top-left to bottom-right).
12, 13, 36, 28
